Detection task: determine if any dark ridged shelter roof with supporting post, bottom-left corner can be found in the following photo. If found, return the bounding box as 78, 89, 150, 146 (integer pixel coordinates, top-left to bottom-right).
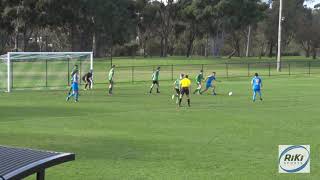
0, 146, 75, 180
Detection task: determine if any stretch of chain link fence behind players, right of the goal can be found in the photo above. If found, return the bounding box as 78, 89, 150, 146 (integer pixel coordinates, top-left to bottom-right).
94, 61, 320, 83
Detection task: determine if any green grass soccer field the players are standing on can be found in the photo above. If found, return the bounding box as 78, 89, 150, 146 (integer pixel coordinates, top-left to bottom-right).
0, 75, 320, 180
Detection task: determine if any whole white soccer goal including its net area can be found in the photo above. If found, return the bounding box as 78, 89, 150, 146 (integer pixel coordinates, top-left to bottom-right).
0, 52, 93, 92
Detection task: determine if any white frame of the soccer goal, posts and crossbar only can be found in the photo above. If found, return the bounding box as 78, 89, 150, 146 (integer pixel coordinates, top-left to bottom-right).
0, 52, 93, 92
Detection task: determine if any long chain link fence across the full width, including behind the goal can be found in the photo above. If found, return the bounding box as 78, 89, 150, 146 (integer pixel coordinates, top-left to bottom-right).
0, 60, 320, 89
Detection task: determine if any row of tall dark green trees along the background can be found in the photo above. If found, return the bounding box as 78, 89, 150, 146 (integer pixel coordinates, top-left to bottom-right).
0, 0, 320, 58
